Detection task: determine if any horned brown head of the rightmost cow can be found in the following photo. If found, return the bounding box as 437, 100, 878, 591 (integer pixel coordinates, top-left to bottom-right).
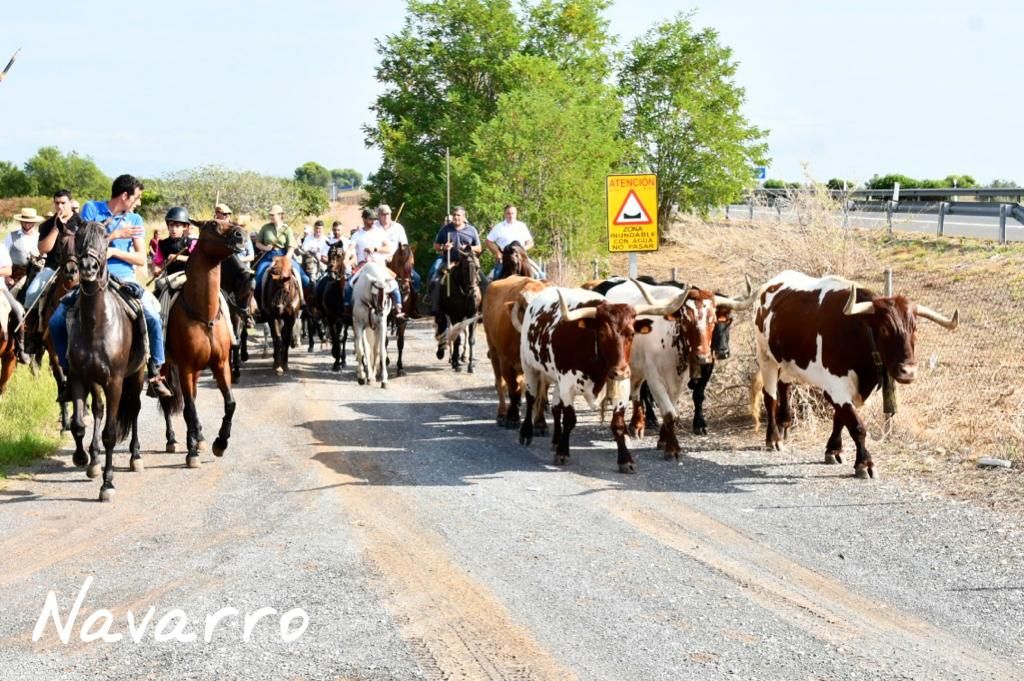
843, 284, 959, 383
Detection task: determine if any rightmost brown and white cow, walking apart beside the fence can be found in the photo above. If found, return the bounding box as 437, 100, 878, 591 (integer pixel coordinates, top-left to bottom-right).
754, 270, 959, 477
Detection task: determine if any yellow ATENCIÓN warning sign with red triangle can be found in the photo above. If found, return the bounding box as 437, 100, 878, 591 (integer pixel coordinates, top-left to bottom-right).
606, 174, 657, 253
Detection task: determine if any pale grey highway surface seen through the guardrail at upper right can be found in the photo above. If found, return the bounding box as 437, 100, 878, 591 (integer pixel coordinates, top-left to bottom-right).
718, 204, 1024, 242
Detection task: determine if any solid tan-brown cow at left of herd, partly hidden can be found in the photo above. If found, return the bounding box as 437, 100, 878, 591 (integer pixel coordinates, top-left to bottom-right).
483, 276, 548, 428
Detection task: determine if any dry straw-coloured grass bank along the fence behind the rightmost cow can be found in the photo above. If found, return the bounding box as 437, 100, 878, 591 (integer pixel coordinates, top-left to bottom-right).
598, 197, 1024, 509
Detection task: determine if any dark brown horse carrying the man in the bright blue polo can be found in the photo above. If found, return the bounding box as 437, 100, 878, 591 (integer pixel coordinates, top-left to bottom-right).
68, 222, 146, 502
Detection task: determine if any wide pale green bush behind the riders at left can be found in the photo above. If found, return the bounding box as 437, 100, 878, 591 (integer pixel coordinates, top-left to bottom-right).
142, 166, 328, 219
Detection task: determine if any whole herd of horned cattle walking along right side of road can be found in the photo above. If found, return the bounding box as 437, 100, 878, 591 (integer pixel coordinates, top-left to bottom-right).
482, 270, 958, 477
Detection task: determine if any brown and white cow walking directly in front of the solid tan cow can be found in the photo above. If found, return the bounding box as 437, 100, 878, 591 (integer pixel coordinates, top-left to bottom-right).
519, 287, 688, 473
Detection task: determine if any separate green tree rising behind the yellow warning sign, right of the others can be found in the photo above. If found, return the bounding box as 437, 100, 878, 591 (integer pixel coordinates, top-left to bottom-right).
618, 15, 768, 225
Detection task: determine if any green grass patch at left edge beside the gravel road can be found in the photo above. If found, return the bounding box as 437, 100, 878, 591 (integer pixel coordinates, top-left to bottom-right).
0, 367, 60, 479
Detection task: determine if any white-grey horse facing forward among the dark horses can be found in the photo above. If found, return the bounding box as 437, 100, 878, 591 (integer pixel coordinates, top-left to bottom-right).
352, 262, 396, 388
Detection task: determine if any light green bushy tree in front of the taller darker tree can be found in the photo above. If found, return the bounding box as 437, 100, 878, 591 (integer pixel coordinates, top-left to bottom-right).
457, 56, 625, 254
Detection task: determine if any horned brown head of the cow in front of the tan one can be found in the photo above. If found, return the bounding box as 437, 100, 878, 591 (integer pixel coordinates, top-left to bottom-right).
558, 291, 687, 381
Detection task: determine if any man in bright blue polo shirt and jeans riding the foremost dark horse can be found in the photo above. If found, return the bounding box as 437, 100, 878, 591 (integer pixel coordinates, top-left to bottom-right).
49, 174, 173, 401
